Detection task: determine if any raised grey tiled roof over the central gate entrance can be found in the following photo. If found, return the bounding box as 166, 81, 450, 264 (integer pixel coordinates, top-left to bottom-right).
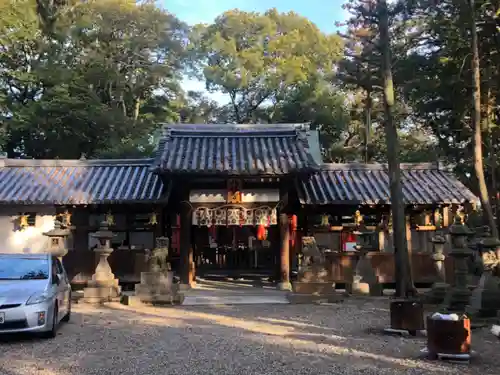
153, 124, 321, 176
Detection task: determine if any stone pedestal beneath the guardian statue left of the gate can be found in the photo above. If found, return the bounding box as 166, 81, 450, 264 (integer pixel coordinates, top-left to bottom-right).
135, 271, 182, 304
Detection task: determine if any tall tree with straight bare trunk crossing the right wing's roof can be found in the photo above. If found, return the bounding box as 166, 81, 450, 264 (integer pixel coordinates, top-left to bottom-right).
343, 0, 416, 297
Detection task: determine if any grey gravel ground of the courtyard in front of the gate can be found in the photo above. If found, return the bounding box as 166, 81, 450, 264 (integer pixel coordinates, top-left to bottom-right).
0, 299, 500, 375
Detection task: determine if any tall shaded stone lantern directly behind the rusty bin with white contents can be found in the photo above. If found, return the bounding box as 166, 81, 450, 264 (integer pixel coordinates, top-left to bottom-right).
444, 215, 472, 313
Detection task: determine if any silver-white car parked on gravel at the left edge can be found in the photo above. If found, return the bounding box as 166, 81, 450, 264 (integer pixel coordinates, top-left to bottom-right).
0, 253, 71, 337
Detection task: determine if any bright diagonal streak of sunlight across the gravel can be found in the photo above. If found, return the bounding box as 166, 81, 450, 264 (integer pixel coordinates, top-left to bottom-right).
99, 305, 466, 374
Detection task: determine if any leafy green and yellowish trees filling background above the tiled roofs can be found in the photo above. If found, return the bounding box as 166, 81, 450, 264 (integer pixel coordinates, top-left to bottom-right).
0, 0, 484, 191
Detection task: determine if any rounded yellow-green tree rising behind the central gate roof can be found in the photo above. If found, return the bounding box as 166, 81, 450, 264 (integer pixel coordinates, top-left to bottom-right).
192, 9, 341, 123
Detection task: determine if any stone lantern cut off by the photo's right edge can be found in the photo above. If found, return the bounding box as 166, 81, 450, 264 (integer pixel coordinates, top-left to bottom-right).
467, 237, 500, 321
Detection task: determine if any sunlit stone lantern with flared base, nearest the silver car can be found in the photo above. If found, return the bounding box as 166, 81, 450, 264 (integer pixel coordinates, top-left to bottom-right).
83, 222, 121, 303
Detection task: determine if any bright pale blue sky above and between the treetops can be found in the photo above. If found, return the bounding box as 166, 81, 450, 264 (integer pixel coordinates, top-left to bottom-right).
160, 0, 346, 103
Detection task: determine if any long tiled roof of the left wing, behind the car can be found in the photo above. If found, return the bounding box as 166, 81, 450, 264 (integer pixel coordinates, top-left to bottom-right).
0, 159, 168, 205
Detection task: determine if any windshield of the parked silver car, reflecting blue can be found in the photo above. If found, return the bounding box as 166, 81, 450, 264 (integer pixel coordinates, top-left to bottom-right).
0, 255, 50, 280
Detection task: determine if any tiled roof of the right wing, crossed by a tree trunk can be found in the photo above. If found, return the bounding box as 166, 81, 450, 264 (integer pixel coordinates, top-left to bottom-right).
297, 163, 478, 205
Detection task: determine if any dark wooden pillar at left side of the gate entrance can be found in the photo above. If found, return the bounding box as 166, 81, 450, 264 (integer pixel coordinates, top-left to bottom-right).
179, 203, 194, 286
